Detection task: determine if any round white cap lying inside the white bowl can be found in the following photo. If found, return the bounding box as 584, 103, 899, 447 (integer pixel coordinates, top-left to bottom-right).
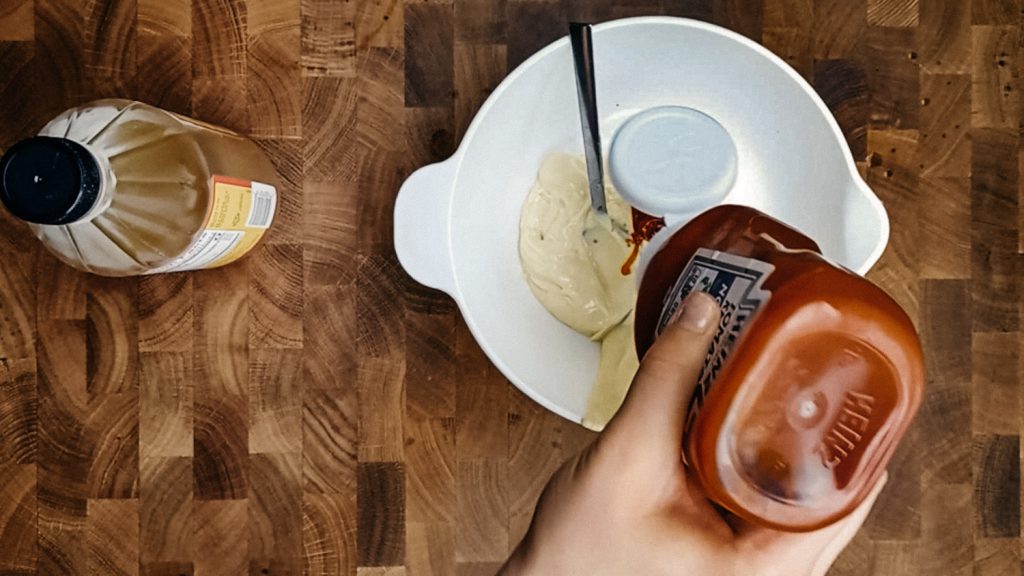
608, 106, 736, 216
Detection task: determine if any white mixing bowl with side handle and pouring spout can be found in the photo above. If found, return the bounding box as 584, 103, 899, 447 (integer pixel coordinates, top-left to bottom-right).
394, 17, 889, 422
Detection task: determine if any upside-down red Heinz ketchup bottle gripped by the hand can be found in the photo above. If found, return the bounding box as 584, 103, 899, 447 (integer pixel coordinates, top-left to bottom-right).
635, 206, 925, 532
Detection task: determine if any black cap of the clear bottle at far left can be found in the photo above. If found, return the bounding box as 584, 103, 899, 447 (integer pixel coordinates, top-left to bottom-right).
0, 136, 100, 225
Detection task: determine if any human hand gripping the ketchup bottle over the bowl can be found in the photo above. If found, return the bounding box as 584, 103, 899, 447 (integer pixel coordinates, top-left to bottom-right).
500, 292, 886, 576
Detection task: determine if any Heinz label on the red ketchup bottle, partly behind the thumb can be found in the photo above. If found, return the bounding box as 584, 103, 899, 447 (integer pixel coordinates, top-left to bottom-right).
657, 248, 775, 433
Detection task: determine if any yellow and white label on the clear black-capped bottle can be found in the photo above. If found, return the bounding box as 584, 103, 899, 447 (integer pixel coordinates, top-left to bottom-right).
151, 176, 278, 274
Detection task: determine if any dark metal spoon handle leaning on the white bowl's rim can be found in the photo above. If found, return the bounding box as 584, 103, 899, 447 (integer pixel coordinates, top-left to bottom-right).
569, 23, 608, 214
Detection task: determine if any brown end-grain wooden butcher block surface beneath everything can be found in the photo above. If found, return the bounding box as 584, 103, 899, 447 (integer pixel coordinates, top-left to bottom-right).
0, 0, 1024, 576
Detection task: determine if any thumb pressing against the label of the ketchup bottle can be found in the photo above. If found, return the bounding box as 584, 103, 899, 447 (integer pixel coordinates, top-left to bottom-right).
604, 292, 721, 457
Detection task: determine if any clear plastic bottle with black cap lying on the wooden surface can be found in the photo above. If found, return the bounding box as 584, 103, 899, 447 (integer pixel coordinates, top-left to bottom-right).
0, 99, 278, 276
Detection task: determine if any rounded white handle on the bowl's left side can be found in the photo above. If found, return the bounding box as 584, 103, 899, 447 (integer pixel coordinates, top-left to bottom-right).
394, 159, 455, 294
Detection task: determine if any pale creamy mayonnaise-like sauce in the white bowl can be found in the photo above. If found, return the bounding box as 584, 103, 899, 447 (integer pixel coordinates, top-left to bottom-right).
519, 154, 639, 429
